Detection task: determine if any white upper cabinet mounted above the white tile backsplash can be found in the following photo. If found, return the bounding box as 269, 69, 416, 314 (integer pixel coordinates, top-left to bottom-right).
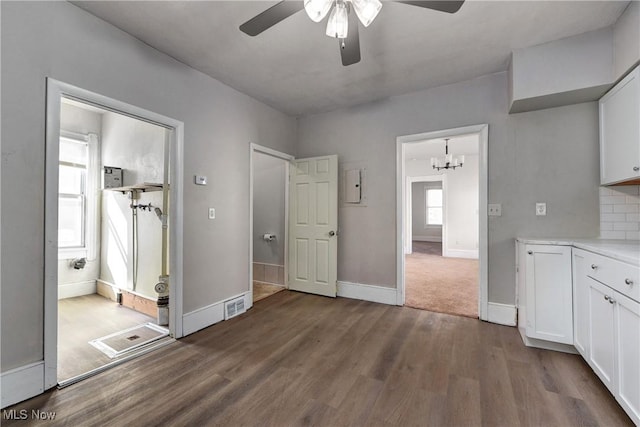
599, 67, 640, 185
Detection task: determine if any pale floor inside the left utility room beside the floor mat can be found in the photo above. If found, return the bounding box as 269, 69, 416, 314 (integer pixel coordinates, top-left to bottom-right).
58, 294, 156, 381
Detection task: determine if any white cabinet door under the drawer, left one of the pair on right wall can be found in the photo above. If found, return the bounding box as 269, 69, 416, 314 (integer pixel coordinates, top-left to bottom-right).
587, 277, 616, 393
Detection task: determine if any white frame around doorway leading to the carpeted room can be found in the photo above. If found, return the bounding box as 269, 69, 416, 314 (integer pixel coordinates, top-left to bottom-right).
396, 124, 489, 320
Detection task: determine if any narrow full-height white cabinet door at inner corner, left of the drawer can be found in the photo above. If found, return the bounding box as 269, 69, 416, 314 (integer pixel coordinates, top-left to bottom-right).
572, 249, 589, 359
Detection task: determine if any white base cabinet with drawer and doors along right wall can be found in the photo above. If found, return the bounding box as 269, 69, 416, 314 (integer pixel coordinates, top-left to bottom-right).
573, 248, 640, 425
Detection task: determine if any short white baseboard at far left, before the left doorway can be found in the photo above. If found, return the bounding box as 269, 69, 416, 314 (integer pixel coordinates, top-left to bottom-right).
0, 361, 44, 409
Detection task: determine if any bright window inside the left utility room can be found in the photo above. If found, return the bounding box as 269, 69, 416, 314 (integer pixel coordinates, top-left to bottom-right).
58, 133, 97, 259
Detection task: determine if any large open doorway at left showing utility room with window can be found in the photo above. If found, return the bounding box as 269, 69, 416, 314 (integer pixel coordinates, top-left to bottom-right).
45, 80, 182, 388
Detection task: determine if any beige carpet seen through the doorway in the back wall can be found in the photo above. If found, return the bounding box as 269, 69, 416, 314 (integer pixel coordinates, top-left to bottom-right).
405, 242, 478, 317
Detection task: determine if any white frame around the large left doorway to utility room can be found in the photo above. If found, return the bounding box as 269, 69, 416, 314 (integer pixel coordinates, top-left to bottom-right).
44, 78, 184, 390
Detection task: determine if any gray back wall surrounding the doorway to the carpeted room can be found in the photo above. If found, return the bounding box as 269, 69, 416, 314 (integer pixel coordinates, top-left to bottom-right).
298, 73, 599, 304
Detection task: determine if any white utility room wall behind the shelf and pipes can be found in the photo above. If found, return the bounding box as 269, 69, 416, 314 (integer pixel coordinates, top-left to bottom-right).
100, 112, 165, 298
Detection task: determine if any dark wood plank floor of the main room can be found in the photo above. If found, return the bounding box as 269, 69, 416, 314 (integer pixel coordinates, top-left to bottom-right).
3, 291, 632, 426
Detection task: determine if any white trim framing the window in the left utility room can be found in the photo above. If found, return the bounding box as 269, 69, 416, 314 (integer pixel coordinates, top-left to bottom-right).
58, 129, 100, 261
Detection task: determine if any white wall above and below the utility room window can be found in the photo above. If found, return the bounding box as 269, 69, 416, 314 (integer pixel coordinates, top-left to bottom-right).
58, 103, 102, 286
